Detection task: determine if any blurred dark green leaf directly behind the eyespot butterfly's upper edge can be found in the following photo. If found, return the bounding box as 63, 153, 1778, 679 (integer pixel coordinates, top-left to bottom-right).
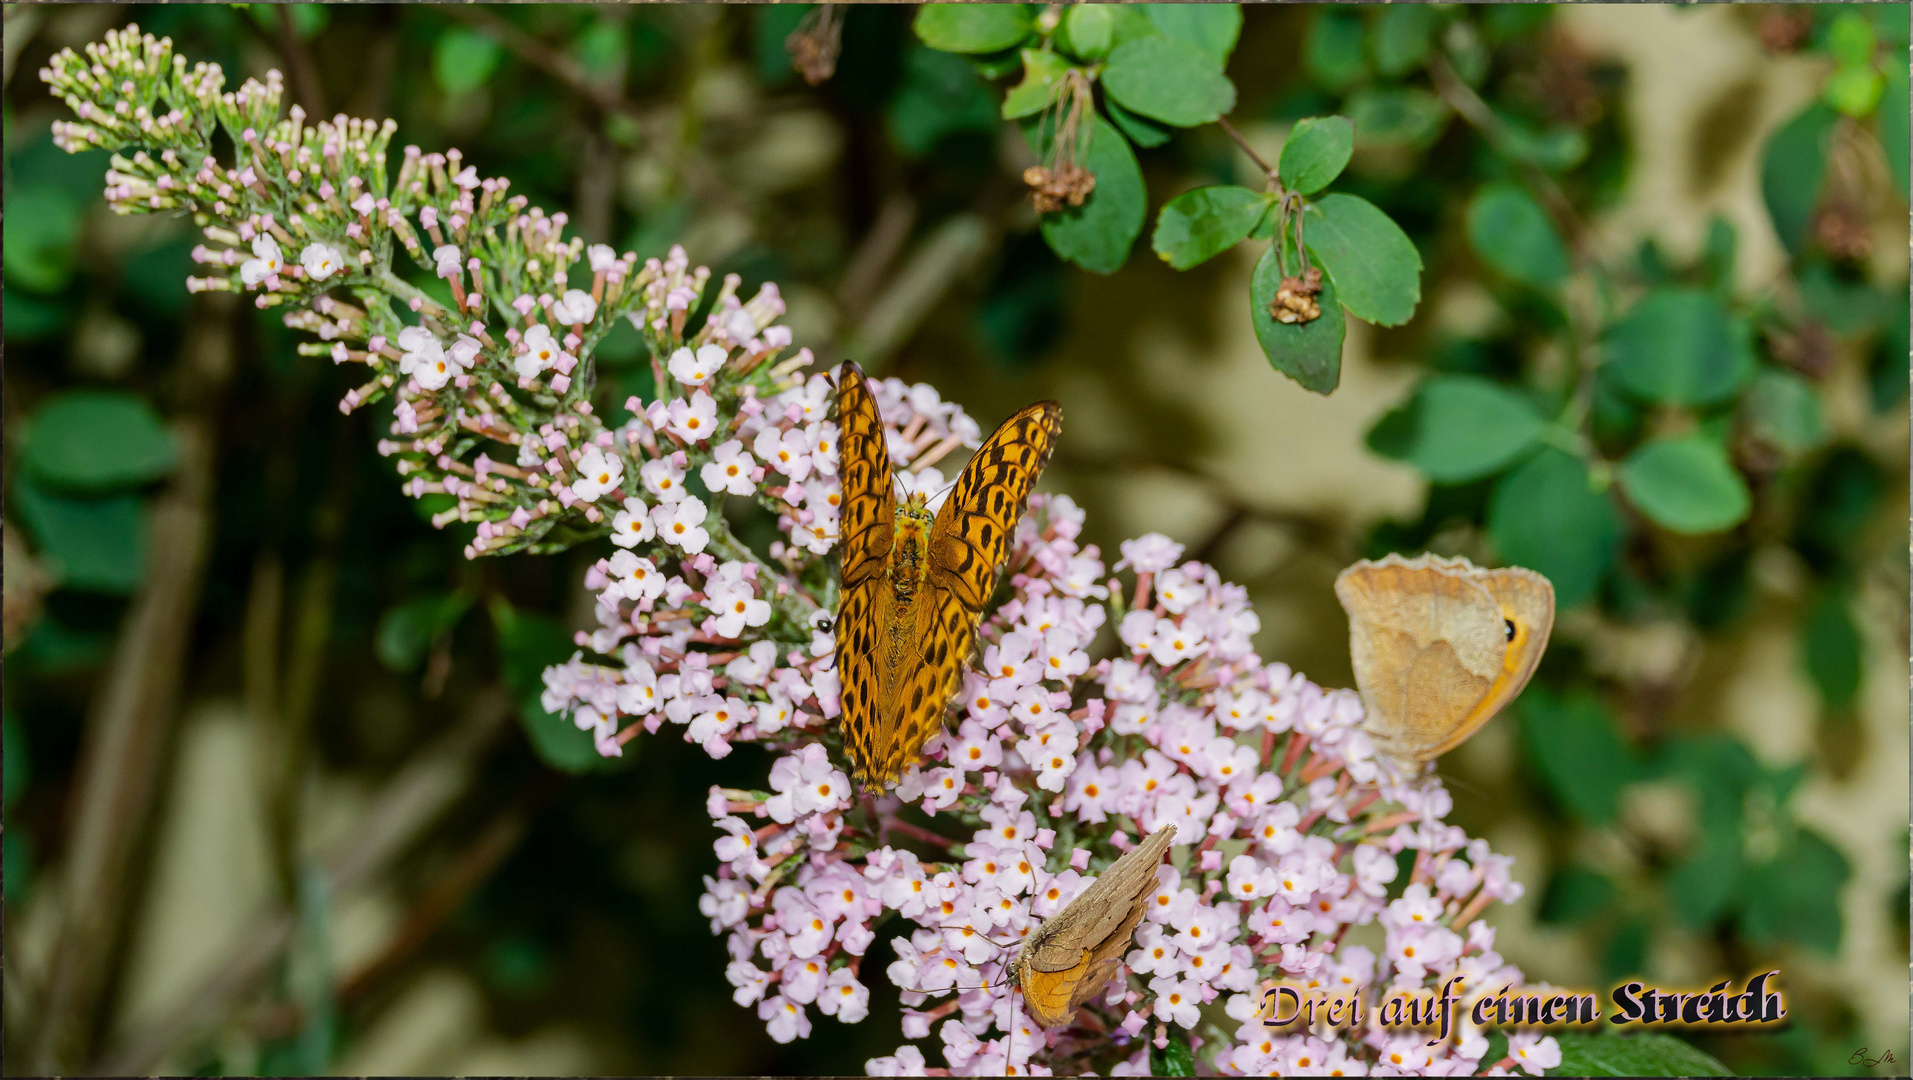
1488, 445, 1624, 610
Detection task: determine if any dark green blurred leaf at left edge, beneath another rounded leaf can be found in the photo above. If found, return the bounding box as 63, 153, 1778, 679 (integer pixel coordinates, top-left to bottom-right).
8, 468, 145, 594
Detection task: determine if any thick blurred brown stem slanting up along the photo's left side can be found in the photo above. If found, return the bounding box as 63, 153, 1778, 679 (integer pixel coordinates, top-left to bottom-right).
29, 292, 235, 1072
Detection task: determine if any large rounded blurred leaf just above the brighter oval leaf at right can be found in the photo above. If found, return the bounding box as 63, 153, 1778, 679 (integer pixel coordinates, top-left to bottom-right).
1601, 289, 1754, 405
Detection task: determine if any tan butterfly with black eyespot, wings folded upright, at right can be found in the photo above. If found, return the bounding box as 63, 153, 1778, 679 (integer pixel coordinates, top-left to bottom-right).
1335, 554, 1553, 774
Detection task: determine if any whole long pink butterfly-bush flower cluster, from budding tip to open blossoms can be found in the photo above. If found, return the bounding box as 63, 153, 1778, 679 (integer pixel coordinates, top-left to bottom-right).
42, 27, 1559, 1074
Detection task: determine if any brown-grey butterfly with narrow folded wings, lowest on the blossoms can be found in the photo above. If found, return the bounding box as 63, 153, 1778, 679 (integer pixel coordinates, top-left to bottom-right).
1010, 826, 1176, 1028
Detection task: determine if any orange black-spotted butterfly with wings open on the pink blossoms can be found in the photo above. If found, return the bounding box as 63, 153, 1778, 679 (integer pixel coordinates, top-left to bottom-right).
836, 363, 1062, 789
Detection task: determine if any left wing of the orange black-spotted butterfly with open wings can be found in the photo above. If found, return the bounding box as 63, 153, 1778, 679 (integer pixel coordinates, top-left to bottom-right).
836, 363, 897, 780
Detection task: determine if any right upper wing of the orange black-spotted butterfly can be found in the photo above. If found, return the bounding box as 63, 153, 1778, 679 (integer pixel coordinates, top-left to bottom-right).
930, 401, 1064, 607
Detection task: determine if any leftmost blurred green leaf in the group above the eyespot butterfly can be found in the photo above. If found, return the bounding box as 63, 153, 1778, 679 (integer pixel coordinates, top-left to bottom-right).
1396, 375, 1544, 484
